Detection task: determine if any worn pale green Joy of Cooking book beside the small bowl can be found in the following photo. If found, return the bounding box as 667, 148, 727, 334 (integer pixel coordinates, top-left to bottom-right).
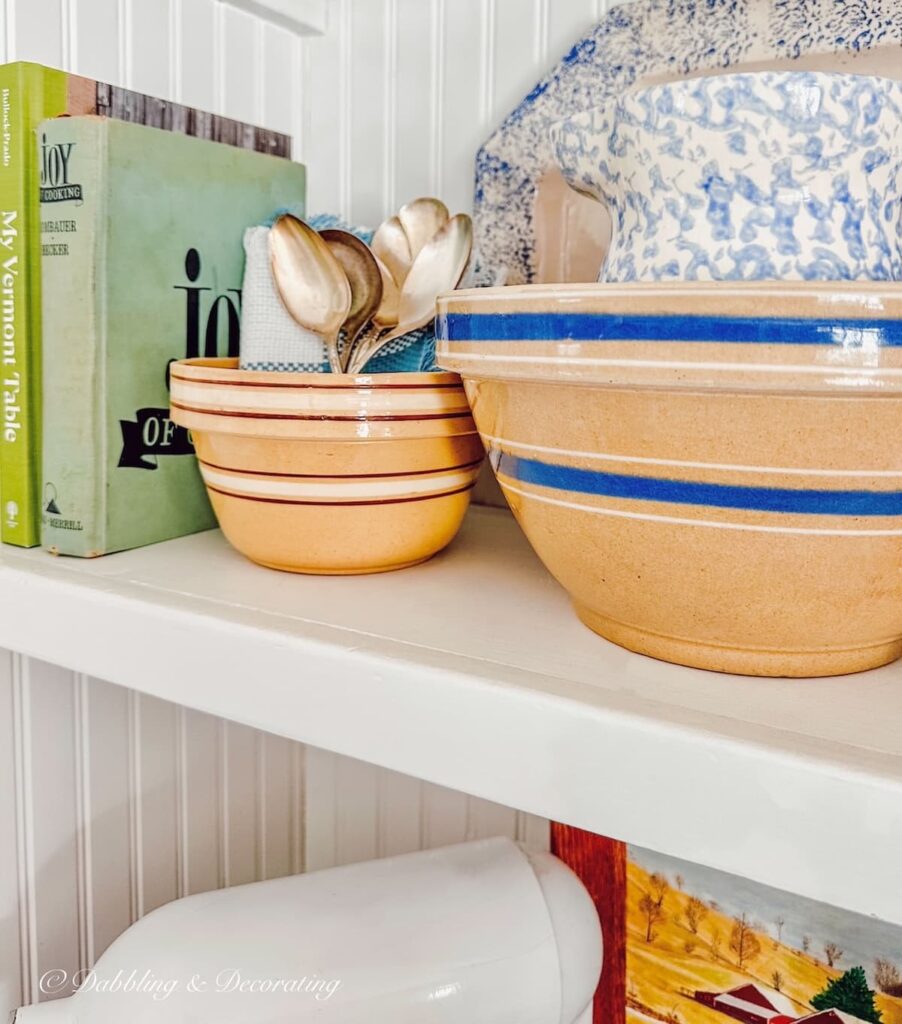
37, 117, 304, 557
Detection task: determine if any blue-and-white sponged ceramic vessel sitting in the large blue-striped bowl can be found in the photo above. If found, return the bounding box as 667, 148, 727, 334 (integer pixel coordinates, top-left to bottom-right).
551, 72, 902, 282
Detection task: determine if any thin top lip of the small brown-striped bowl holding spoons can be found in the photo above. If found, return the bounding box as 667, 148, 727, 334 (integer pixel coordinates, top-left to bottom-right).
169, 356, 463, 391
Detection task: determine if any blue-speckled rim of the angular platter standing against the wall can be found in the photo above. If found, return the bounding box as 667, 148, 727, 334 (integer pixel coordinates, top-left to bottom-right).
474, 0, 902, 284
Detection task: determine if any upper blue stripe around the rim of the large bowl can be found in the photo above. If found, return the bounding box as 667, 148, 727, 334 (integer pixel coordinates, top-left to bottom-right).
437, 312, 902, 349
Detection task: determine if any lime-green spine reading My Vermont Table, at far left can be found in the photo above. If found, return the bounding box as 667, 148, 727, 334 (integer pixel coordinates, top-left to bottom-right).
0, 63, 67, 548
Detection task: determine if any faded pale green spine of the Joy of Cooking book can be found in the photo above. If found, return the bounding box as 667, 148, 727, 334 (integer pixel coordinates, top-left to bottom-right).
37, 119, 109, 557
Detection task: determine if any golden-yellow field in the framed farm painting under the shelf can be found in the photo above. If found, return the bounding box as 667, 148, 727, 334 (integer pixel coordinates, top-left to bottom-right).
627, 862, 902, 1024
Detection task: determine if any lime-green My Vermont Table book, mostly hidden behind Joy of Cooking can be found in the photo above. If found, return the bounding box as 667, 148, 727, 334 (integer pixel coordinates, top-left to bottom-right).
0, 61, 291, 547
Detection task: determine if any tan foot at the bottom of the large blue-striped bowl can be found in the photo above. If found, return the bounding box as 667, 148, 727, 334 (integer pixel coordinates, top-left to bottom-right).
574, 603, 902, 679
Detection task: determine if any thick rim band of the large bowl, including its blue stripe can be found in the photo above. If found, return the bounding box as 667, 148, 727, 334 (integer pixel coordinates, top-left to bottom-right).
436, 282, 902, 395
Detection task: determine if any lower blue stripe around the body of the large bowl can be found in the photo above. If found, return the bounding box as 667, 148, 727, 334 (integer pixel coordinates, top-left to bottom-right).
491, 451, 902, 516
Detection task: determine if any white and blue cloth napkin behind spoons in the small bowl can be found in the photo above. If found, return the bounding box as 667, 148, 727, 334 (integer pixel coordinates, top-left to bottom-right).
240, 215, 435, 374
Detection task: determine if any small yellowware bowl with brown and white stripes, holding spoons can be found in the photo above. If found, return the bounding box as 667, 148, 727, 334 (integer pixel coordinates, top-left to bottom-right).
171, 359, 483, 574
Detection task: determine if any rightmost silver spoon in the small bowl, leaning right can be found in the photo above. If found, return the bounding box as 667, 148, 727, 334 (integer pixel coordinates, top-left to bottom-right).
348, 213, 473, 373
